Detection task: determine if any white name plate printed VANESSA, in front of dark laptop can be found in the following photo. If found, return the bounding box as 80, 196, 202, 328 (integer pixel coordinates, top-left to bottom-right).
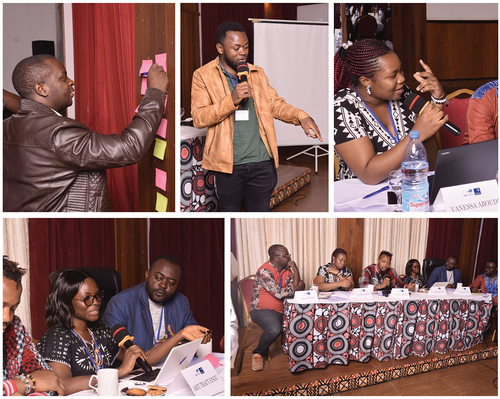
433, 180, 498, 212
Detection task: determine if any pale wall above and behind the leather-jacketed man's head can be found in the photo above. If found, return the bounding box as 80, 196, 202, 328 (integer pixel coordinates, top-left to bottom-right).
3, 3, 64, 93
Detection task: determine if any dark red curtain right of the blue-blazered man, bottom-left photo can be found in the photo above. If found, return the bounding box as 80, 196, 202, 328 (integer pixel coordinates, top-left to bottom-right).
149, 219, 228, 351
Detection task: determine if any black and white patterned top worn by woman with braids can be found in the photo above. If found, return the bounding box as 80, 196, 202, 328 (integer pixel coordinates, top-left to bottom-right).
333, 87, 417, 180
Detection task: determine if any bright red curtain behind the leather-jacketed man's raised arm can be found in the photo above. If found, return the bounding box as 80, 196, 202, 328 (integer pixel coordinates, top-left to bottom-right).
73, 3, 139, 212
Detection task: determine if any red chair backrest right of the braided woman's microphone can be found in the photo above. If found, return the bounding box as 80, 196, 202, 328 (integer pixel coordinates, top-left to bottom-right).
436, 89, 474, 150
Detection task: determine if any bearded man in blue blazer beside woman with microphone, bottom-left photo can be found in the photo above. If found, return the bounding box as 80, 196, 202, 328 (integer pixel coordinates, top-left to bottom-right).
102, 255, 211, 351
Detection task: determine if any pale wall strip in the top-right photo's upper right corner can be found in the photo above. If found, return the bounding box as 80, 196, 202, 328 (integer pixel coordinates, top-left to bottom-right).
427, 3, 498, 21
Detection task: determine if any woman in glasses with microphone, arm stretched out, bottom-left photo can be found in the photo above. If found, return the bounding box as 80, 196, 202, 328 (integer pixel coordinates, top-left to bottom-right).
37, 269, 204, 395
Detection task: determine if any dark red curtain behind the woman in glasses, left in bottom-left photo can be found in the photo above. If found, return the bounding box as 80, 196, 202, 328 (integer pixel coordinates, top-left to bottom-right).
28, 219, 115, 339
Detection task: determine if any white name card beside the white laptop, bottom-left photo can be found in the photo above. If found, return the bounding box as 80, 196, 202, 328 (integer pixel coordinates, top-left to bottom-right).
171, 360, 224, 396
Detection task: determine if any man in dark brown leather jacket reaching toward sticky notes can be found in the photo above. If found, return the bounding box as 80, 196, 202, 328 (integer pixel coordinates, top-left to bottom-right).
3, 55, 169, 216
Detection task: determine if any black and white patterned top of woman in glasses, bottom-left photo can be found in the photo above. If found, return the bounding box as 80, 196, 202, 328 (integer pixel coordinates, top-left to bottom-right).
37, 324, 120, 377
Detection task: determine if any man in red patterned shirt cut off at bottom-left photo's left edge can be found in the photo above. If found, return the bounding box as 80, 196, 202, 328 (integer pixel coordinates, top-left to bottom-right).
3, 256, 64, 396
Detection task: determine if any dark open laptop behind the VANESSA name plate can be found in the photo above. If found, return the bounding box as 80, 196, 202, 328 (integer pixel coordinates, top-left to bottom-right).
429, 139, 498, 205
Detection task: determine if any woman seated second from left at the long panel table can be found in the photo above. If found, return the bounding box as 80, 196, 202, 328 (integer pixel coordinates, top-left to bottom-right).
315, 248, 354, 291
